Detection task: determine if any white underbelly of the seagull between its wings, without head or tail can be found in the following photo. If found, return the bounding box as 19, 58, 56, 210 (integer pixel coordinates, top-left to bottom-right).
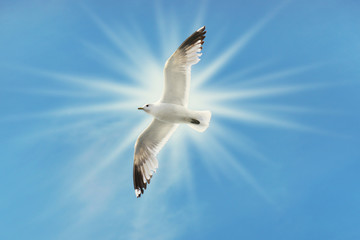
154, 103, 191, 123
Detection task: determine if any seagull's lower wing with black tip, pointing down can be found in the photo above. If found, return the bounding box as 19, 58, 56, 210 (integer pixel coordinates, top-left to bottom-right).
133, 119, 178, 197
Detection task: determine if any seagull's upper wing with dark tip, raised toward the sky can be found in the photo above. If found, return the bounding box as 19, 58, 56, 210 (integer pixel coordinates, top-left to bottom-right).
160, 26, 206, 107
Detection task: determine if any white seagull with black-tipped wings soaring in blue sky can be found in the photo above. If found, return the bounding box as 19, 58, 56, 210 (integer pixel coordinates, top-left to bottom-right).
133, 26, 211, 198
